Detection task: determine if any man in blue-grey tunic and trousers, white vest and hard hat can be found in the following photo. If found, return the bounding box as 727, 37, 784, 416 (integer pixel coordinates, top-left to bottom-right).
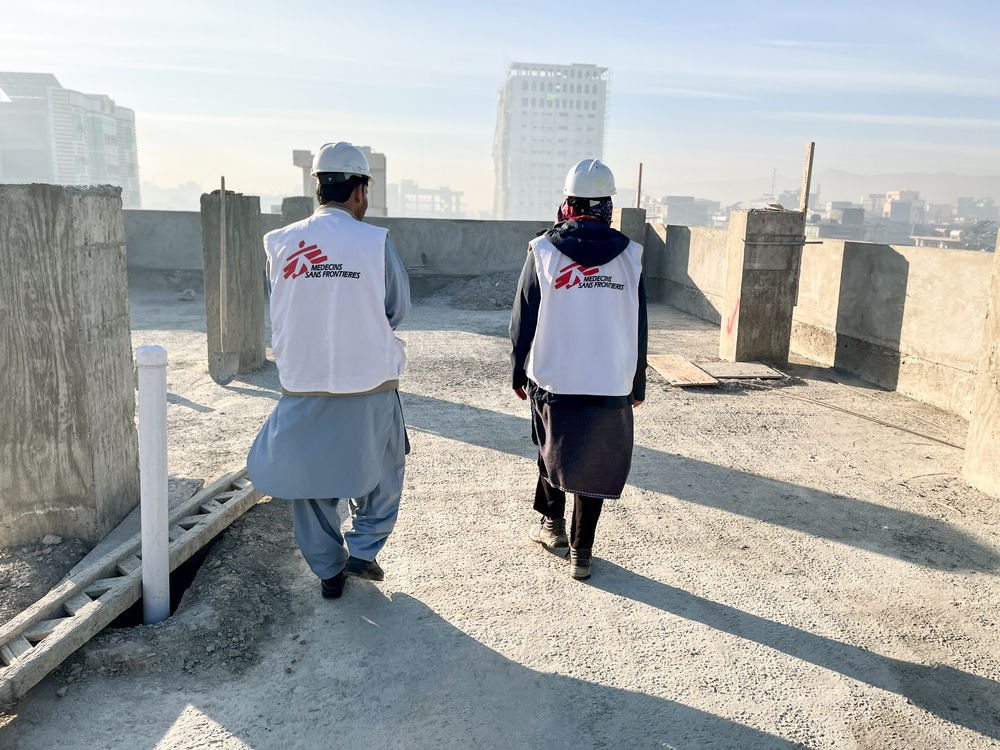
247, 142, 410, 598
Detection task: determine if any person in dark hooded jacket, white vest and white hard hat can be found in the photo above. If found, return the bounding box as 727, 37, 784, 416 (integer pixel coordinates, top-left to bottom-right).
510, 159, 647, 579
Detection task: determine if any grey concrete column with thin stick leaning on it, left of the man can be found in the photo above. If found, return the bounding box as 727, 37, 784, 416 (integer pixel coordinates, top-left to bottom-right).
201, 194, 265, 372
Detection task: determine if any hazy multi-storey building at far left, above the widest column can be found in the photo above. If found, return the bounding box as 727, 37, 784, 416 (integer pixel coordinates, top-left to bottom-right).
0, 72, 141, 208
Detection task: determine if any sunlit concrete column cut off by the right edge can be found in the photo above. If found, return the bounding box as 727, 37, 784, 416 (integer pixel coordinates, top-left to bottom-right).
965, 232, 1000, 497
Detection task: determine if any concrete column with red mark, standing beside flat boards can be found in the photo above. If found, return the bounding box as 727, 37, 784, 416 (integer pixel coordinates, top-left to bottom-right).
719, 210, 805, 364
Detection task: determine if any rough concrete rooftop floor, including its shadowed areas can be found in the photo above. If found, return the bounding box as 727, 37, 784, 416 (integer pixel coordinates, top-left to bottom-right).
0, 293, 1000, 750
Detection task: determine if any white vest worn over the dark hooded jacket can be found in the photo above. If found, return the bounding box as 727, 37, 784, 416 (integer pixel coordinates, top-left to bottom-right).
525, 236, 642, 396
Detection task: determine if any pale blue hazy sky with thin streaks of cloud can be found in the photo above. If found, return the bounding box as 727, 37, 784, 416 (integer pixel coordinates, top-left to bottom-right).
0, 0, 1000, 210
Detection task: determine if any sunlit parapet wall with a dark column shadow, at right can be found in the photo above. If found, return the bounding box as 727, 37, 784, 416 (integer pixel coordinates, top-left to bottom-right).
792, 240, 993, 417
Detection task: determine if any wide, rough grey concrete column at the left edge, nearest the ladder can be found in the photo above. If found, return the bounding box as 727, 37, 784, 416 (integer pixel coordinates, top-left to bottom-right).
0, 185, 139, 546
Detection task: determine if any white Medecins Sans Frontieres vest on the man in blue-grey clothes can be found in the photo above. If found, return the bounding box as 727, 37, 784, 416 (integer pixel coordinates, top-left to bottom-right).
264, 208, 406, 393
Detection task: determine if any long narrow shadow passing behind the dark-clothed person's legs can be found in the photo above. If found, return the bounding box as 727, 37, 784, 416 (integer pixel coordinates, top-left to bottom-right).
402, 393, 1000, 572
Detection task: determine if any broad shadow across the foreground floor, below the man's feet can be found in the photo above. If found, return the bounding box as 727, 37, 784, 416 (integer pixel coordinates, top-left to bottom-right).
0, 592, 803, 750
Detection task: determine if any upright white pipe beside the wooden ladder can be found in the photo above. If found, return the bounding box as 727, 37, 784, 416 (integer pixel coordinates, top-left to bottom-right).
135, 346, 170, 625
